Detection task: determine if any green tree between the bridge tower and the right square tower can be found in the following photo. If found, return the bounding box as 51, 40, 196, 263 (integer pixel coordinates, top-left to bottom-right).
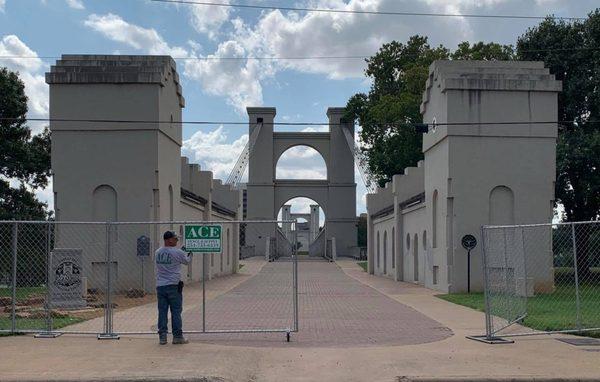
345, 36, 514, 186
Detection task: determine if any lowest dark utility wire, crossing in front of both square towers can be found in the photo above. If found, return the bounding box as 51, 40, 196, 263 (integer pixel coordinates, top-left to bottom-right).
0, 117, 600, 129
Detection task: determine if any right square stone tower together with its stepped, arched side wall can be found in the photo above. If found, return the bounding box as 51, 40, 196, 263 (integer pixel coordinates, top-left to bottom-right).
367, 61, 562, 293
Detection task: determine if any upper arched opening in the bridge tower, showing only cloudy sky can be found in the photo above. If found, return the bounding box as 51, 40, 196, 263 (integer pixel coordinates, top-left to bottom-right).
275, 145, 327, 180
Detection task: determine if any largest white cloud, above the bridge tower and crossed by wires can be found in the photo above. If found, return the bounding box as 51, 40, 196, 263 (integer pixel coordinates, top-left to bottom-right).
173, 0, 596, 114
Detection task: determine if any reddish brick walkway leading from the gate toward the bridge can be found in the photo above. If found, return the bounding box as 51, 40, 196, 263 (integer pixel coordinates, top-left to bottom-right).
183, 262, 452, 347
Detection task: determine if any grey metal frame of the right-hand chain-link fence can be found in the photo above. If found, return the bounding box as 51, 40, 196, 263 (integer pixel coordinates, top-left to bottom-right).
467, 221, 600, 344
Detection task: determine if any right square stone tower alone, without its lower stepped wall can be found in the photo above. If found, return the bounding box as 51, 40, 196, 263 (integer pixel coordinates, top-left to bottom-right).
421, 61, 562, 292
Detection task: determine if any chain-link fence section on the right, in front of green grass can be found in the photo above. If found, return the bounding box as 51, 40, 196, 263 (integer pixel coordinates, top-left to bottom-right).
482, 222, 600, 340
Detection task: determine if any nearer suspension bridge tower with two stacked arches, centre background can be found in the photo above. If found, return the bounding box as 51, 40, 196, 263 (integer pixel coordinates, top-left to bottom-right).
247, 108, 357, 256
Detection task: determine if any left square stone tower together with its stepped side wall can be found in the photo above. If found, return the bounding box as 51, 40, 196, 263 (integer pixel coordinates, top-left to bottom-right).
46, 55, 241, 289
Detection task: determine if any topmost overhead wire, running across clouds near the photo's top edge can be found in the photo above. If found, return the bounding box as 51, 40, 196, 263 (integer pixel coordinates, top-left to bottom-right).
150, 0, 585, 21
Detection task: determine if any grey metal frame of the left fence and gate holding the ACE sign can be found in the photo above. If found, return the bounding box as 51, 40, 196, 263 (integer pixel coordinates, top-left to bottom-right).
0, 220, 299, 342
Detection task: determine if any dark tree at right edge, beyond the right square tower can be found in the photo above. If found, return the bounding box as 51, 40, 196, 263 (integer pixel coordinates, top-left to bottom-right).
517, 9, 600, 278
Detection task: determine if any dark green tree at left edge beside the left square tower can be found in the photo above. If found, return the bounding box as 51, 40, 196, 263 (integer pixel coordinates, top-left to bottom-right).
0, 68, 50, 220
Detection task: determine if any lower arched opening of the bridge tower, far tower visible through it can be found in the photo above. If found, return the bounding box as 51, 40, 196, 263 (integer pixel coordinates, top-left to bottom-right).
277, 197, 326, 255
